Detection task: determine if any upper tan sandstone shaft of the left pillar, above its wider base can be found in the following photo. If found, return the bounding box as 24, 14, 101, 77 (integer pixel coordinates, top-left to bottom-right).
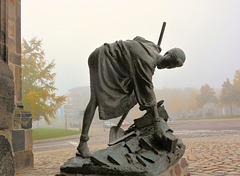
1, 0, 22, 106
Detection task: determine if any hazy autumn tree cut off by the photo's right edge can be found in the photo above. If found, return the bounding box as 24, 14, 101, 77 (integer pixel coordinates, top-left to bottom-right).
233, 70, 240, 105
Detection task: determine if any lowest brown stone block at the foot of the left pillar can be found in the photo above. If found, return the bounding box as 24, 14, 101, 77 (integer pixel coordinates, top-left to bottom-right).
14, 151, 33, 170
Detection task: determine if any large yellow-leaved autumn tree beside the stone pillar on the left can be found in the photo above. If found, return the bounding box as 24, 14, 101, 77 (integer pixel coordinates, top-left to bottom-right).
22, 38, 66, 123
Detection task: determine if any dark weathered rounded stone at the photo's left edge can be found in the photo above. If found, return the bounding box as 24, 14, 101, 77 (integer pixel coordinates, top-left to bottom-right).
0, 58, 14, 175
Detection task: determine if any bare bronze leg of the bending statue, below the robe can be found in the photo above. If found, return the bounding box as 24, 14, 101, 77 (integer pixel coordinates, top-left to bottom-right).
77, 94, 97, 158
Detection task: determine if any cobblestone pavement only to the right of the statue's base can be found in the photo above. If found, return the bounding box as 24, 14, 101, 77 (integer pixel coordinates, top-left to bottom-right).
183, 135, 240, 176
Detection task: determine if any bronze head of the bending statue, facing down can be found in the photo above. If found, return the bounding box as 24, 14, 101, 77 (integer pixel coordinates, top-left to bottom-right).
157, 48, 186, 69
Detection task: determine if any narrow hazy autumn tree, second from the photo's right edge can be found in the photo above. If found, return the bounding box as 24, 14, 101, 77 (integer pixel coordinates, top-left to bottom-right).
220, 79, 234, 115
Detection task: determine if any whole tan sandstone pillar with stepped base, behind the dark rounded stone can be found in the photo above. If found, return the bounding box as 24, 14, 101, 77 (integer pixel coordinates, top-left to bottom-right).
0, 0, 33, 172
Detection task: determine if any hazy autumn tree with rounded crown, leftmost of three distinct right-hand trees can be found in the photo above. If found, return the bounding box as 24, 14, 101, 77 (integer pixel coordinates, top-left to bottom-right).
197, 84, 217, 107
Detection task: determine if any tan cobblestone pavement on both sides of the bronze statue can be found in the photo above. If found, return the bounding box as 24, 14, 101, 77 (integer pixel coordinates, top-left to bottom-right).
16, 131, 240, 176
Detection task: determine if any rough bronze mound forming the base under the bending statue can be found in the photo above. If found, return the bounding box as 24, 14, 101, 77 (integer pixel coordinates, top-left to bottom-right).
59, 101, 189, 176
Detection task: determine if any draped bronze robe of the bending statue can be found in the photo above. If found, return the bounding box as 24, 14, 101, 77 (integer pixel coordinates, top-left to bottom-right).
88, 37, 161, 120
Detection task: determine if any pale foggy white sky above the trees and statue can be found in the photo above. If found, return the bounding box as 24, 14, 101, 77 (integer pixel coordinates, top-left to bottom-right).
22, 0, 240, 94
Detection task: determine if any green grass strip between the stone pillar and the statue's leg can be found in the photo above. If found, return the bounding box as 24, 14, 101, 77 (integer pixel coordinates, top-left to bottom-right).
33, 128, 80, 140
